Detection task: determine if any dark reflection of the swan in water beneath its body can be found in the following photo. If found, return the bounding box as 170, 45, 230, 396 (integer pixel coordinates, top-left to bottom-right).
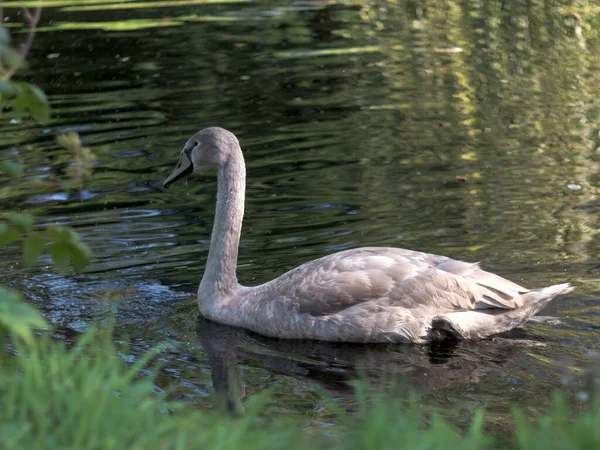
195, 315, 539, 412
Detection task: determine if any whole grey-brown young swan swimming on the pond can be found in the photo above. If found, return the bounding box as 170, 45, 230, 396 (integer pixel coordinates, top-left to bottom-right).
163, 127, 572, 343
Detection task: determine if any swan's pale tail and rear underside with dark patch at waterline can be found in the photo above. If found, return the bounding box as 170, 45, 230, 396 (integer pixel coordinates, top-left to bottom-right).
428, 283, 573, 341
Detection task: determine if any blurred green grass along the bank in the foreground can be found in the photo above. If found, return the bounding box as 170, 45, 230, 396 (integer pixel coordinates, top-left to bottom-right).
0, 322, 600, 450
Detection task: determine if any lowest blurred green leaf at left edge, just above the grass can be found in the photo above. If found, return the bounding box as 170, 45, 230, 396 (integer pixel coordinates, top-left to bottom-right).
0, 287, 48, 344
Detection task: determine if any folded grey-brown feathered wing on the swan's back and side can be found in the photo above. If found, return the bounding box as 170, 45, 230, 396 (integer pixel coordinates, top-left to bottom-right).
275, 247, 527, 316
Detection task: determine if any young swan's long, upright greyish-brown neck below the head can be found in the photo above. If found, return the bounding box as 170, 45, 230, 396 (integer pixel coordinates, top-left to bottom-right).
198, 147, 246, 309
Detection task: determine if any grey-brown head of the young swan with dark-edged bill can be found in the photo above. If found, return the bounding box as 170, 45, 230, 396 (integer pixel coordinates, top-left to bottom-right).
163, 127, 240, 188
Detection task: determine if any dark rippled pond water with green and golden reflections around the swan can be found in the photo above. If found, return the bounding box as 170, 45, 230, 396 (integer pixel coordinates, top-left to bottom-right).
0, 0, 600, 429
